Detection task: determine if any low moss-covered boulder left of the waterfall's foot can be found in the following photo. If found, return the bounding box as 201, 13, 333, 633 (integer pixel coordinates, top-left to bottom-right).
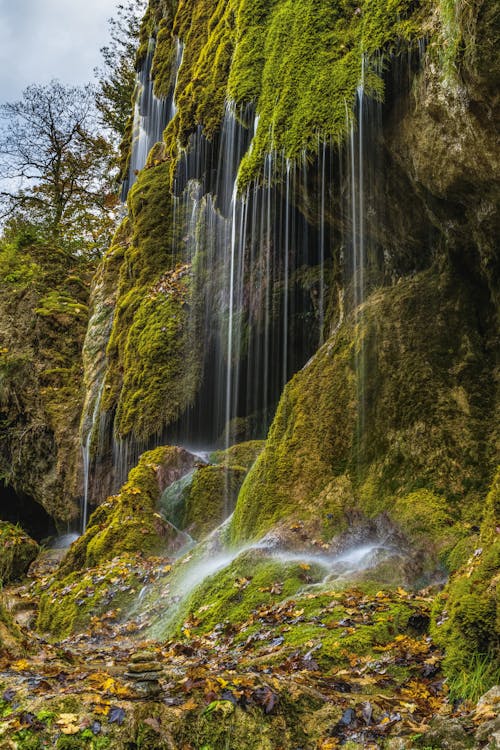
60, 446, 195, 576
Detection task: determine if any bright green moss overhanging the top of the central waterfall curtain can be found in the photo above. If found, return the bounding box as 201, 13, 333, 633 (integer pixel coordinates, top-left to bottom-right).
153, 0, 427, 188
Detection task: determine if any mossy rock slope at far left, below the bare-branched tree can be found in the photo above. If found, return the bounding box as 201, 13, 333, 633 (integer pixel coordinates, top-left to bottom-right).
0, 227, 94, 523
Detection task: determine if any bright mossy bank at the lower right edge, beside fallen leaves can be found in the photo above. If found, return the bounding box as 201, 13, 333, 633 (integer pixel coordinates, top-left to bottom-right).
432, 471, 500, 699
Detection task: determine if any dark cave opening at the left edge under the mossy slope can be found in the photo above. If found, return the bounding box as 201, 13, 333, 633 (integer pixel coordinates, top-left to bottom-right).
0, 482, 57, 542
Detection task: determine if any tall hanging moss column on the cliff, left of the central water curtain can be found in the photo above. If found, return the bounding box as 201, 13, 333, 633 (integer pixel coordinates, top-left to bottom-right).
102, 164, 201, 442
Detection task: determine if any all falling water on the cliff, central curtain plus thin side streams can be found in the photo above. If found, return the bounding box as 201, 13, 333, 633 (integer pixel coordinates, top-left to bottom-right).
89, 42, 386, 511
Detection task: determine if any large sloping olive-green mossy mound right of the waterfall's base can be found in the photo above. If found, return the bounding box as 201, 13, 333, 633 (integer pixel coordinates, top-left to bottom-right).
231, 269, 494, 555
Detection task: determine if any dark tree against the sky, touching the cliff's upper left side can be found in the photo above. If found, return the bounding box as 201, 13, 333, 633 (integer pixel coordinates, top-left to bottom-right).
95, 0, 146, 143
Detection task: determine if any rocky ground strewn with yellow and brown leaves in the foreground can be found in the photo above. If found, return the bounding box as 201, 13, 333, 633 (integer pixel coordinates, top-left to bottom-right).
0, 553, 500, 750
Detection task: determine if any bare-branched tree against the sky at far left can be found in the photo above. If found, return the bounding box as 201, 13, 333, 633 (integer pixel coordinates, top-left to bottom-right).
0, 80, 116, 254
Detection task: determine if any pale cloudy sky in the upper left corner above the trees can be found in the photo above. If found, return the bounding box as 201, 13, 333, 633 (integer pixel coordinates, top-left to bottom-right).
0, 0, 119, 103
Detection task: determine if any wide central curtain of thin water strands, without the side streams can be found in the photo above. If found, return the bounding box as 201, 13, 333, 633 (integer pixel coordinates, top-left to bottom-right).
160, 102, 331, 458
